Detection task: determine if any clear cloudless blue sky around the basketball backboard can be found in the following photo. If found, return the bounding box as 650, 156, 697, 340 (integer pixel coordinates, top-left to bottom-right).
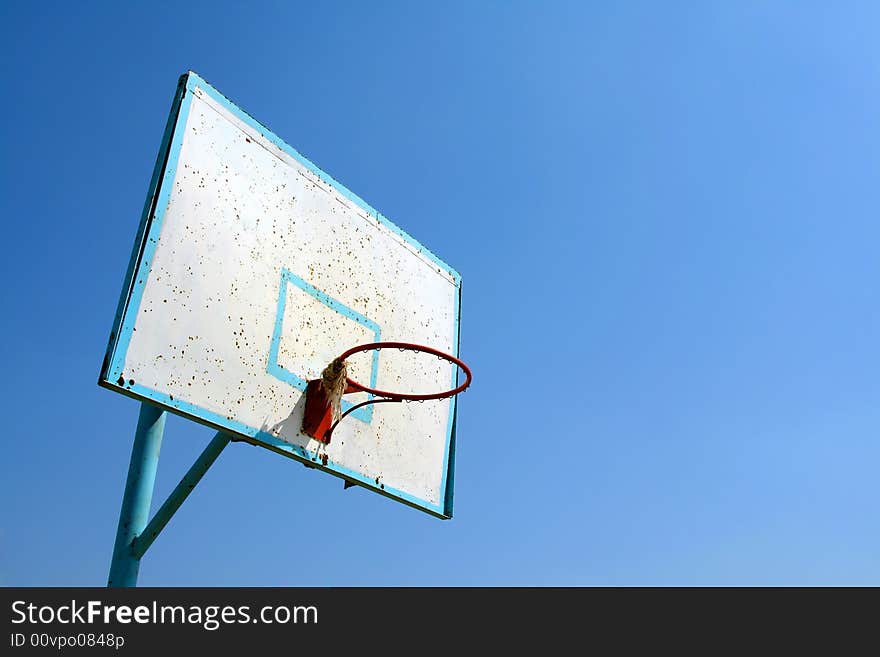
0, 1, 880, 585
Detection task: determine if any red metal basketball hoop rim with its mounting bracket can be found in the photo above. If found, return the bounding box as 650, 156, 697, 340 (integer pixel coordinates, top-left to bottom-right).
302, 342, 473, 444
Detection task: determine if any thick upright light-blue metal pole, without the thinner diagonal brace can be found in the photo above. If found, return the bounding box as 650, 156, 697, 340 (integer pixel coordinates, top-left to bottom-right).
107, 402, 166, 587
